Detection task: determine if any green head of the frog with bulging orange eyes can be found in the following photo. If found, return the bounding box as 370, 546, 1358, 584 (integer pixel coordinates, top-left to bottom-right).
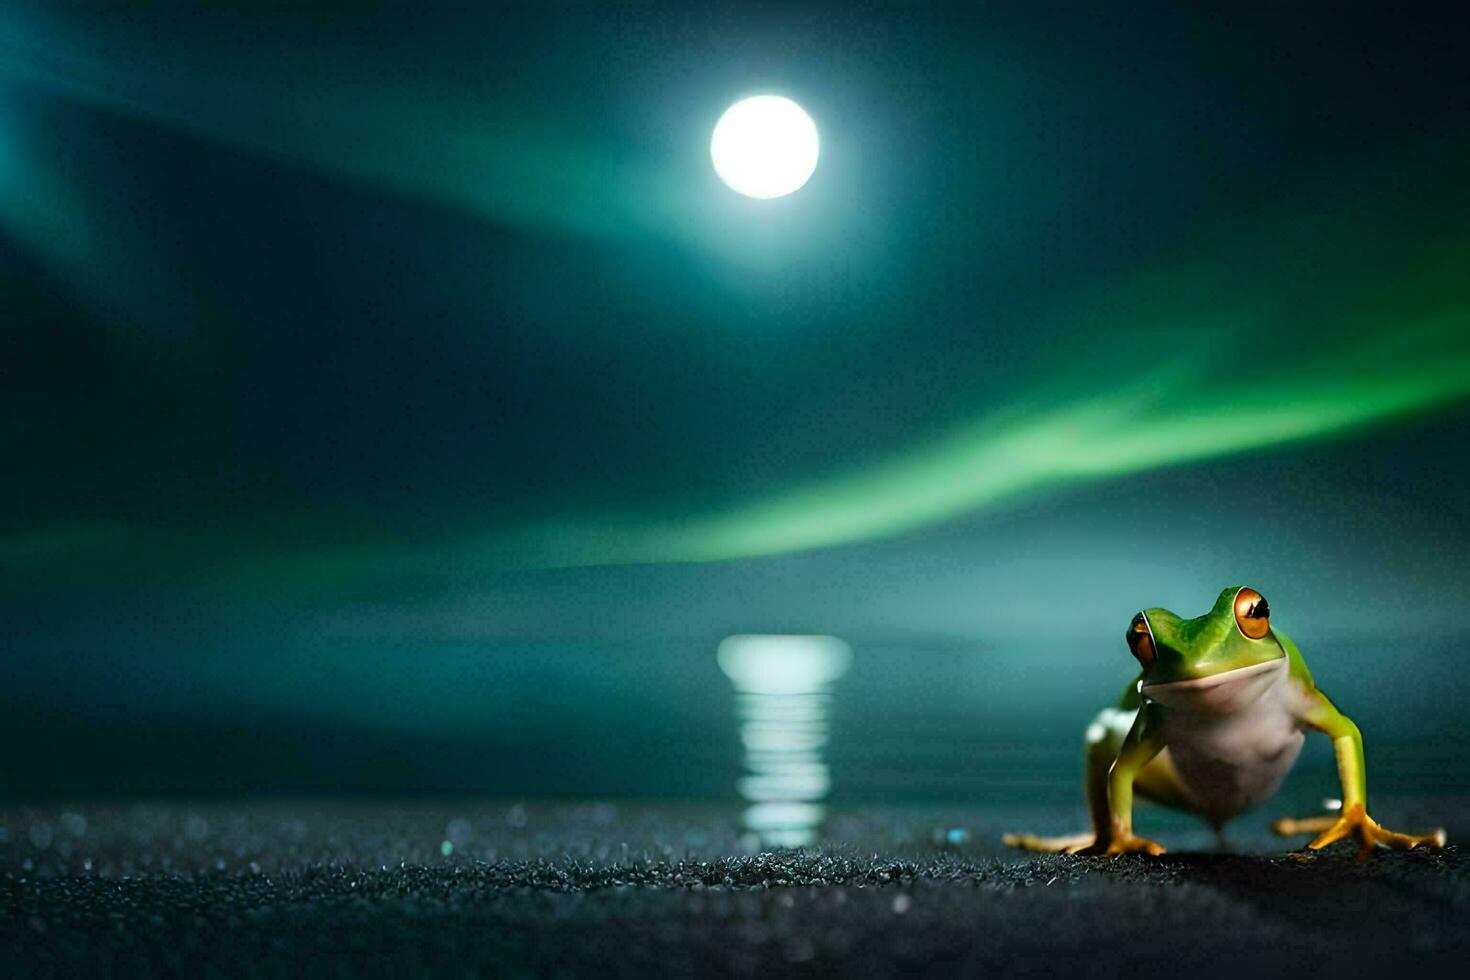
1127, 585, 1286, 714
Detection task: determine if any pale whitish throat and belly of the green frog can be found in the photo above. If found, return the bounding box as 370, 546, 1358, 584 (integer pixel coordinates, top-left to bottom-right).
1145, 657, 1305, 824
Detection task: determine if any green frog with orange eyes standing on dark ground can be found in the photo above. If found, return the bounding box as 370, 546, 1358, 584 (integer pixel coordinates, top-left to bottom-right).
1004, 585, 1445, 857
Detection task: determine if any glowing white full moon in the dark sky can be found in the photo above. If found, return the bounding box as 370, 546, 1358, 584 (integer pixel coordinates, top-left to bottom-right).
710, 96, 817, 198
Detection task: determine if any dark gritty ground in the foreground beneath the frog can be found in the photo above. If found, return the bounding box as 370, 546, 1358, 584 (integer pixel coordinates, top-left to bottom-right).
0, 799, 1470, 977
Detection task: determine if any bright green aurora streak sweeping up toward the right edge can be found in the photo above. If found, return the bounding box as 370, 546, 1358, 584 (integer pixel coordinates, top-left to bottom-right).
301, 148, 1470, 577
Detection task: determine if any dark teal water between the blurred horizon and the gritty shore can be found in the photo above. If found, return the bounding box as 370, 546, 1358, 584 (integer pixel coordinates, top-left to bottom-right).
0, 639, 1470, 840
